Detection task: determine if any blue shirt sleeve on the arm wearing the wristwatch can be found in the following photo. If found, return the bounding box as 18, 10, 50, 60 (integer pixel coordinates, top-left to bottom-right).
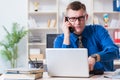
96, 27, 119, 61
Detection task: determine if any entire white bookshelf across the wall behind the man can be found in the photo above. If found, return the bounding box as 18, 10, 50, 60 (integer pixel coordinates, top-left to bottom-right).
28, 0, 120, 66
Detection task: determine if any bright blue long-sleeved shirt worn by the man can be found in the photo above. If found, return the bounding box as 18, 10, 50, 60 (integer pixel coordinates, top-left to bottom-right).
54, 25, 119, 71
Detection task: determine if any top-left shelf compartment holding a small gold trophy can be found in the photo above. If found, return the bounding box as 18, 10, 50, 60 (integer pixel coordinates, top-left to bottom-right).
28, 0, 57, 11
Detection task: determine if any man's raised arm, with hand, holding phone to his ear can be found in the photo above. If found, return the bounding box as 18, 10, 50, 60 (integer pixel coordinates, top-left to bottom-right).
54, 17, 71, 48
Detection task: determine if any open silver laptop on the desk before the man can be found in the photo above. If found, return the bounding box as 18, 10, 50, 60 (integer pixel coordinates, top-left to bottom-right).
46, 48, 91, 77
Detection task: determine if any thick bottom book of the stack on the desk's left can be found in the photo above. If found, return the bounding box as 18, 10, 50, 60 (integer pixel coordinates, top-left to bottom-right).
2, 72, 43, 80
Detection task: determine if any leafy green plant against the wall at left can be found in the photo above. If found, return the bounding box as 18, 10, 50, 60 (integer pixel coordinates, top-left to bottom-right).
0, 22, 28, 68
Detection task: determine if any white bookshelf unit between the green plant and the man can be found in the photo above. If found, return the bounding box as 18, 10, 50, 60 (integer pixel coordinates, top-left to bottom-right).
28, 0, 58, 61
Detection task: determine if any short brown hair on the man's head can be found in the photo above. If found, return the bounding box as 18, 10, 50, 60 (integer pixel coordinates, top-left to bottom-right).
66, 1, 86, 11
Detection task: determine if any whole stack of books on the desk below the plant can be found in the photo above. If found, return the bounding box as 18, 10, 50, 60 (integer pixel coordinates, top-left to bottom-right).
2, 68, 44, 80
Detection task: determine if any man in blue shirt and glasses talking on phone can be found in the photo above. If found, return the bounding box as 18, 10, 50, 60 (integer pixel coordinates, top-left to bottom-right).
54, 1, 119, 71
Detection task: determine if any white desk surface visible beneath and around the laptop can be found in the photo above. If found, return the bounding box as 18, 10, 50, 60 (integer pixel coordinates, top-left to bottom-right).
37, 72, 120, 80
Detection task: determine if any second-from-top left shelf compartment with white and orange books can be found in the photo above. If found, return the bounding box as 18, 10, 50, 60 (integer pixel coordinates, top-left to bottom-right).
28, 12, 58, 29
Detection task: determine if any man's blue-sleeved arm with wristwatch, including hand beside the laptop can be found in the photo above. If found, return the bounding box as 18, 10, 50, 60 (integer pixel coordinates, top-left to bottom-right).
88, 26, 119, 71
